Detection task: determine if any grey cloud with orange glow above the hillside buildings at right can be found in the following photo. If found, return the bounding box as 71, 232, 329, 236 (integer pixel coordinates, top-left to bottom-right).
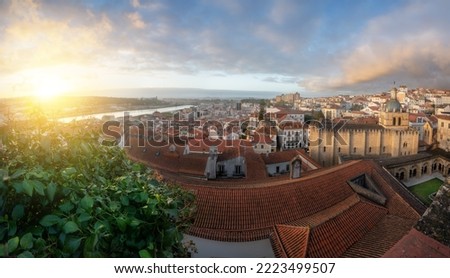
326, 1, 450, 92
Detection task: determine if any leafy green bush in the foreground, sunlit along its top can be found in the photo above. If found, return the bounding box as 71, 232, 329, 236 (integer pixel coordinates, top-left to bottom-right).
0, 118, 194, 258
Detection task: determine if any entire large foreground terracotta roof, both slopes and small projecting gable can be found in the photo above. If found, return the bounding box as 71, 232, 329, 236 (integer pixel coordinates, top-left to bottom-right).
185, 161, 419, 257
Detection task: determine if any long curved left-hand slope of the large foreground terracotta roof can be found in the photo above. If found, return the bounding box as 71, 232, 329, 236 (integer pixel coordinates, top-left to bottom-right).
189, 161, 370, 241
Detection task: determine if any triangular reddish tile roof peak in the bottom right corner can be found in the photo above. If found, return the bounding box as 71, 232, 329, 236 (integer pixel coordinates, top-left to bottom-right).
383, 229, 450, 258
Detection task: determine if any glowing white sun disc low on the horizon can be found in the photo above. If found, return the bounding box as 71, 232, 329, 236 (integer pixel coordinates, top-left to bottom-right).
34, 76, 70, 101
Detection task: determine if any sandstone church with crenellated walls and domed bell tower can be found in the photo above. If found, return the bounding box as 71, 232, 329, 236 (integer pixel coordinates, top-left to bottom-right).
309, 88, 419, 167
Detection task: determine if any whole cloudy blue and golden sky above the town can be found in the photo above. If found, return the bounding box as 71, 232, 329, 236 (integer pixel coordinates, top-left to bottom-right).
0, 0, 450, 97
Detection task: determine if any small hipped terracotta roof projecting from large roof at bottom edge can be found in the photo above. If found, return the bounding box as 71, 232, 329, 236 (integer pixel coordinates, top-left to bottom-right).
270, 225, 309, 258
